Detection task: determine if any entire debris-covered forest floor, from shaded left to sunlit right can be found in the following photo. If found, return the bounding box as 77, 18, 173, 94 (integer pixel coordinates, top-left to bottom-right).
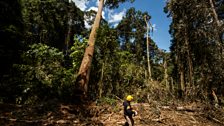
0, 101, 224, 126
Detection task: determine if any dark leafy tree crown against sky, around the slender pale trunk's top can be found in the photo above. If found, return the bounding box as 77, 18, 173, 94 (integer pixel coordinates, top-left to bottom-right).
116, 7, 159, 63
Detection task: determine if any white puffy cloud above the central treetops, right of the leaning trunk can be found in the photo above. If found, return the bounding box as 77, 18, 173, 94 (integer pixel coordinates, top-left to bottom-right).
108, 9, 126, 23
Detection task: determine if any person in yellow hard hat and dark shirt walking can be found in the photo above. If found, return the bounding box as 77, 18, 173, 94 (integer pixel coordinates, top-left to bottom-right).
123, 95, 137, 126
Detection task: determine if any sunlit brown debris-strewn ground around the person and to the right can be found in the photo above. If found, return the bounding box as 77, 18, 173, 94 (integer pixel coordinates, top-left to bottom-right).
100, 103, 224, 126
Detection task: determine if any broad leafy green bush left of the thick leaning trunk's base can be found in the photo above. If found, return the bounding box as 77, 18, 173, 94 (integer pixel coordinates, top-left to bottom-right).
15, 44, 73, 103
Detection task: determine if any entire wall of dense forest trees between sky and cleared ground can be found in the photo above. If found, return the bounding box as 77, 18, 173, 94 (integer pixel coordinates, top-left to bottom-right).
0, 0, 224, 108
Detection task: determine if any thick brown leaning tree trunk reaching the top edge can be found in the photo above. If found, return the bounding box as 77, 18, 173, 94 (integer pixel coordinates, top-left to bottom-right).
76, 0, 104, 96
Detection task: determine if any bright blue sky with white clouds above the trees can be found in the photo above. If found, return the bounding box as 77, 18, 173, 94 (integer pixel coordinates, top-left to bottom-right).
73, 0, 171, 51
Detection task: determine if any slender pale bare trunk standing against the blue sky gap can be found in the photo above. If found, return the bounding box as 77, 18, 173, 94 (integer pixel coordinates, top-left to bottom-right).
145, 16, 152, 81
